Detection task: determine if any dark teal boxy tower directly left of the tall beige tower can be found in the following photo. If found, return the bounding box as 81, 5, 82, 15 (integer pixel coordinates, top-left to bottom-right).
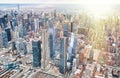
32, 40, 41, 67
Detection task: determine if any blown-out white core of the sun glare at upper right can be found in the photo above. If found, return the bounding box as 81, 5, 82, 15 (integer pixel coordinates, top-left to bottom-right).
82, 0, 114, 16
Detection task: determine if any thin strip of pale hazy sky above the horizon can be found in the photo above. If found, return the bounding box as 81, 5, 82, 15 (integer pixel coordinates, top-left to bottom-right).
0, 0, 120, 4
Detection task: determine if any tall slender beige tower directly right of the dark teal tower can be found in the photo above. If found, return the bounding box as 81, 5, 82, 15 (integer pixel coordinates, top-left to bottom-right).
41, 29, 50, 69
